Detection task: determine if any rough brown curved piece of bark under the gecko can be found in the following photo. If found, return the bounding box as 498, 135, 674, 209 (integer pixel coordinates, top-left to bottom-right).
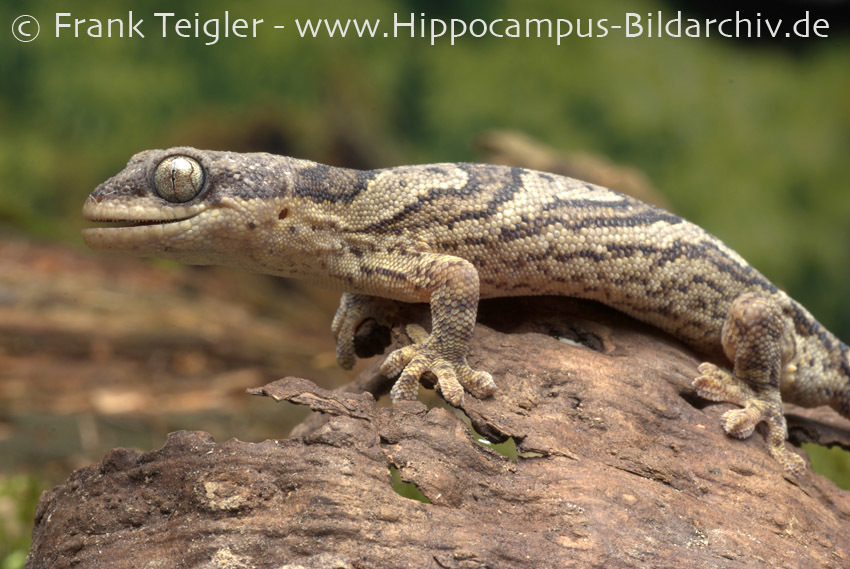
28, 299, 850, 569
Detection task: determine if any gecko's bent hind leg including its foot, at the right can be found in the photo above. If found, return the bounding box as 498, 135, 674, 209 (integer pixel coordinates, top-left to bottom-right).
693, 293, 805, 474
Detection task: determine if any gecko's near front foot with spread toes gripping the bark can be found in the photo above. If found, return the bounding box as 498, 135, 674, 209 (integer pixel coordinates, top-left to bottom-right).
381, 324, 496, 406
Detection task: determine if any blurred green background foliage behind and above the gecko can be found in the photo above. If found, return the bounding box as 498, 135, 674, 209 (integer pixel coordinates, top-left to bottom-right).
0, 0, 850, 568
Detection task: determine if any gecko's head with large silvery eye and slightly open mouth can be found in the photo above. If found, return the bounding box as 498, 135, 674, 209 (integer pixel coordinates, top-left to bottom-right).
82, 147, 289, 264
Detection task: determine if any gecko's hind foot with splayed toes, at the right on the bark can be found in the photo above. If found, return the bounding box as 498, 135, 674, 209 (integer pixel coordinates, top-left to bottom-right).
693, 363, 806, 475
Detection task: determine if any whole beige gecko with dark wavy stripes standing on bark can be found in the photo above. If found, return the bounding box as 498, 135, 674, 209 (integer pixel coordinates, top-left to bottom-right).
82, 147, 850, 474
